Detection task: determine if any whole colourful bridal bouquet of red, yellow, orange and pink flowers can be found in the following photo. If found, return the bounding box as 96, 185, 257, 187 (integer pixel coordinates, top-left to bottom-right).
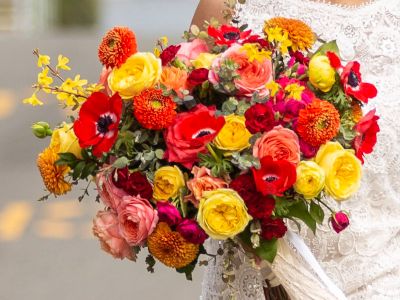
24, 5, 379, 279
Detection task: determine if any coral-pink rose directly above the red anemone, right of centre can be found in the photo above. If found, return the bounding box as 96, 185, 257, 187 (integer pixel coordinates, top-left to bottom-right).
253, 126, 300, 165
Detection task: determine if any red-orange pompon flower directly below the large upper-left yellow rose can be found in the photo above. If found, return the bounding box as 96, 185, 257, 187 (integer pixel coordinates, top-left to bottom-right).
133, 89, 176, 130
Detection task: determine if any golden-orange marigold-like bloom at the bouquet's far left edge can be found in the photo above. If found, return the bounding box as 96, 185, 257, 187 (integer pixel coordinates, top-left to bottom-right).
36, 147, 71, 195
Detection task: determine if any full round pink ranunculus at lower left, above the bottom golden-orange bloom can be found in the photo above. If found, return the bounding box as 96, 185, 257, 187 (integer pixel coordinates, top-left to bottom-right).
117, 196, 158, 246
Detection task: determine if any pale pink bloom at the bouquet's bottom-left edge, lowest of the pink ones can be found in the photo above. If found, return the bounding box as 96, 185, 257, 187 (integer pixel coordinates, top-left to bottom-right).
93, 211, 136, 261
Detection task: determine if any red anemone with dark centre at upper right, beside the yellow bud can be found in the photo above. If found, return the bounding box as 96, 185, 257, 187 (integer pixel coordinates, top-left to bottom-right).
327, 52, 378, 103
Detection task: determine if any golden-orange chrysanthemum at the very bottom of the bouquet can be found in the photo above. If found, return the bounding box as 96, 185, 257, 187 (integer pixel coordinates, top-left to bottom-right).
147, 222, 199, 269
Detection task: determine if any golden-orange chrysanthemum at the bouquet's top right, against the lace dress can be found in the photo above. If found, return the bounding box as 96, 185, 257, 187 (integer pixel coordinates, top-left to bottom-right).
264, 17, 315, 51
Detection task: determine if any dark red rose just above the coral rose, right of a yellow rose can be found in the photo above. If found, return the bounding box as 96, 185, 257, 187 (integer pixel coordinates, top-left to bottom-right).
244, 102, 277, 134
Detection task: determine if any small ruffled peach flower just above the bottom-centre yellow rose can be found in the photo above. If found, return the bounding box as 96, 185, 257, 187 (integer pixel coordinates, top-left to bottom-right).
186, 166, 228, 207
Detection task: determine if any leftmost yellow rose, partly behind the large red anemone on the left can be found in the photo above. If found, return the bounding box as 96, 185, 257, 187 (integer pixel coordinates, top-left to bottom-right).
50, 123, 82, 159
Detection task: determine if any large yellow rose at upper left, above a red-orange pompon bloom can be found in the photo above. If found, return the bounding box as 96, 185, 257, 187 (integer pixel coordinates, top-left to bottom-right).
108, 52, 162, 99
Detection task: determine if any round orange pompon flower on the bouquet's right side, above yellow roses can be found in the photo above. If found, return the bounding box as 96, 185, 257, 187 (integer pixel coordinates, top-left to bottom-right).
297, 99, 340, 147
